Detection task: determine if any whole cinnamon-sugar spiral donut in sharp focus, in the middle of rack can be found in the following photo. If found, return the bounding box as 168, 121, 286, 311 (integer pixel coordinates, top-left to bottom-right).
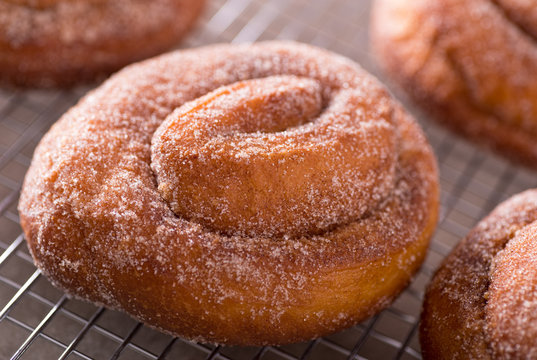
19, 42, 438, 345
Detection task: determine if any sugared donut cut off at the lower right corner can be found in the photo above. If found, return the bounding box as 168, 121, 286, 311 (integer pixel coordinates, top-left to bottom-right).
420, 190, 537, 359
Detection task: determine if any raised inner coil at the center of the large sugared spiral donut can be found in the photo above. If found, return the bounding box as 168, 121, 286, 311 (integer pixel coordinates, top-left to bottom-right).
152, 76, 395, 237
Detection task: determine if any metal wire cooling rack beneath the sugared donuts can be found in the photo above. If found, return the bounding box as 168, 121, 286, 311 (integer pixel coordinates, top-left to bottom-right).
0, 0, 536, 360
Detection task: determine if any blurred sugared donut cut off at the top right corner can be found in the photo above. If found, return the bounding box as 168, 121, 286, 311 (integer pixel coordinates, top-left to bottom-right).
371, 0, 537, 167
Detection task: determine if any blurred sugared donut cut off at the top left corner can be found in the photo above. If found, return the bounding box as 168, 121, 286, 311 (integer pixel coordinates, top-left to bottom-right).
0, 0, 204, 87
